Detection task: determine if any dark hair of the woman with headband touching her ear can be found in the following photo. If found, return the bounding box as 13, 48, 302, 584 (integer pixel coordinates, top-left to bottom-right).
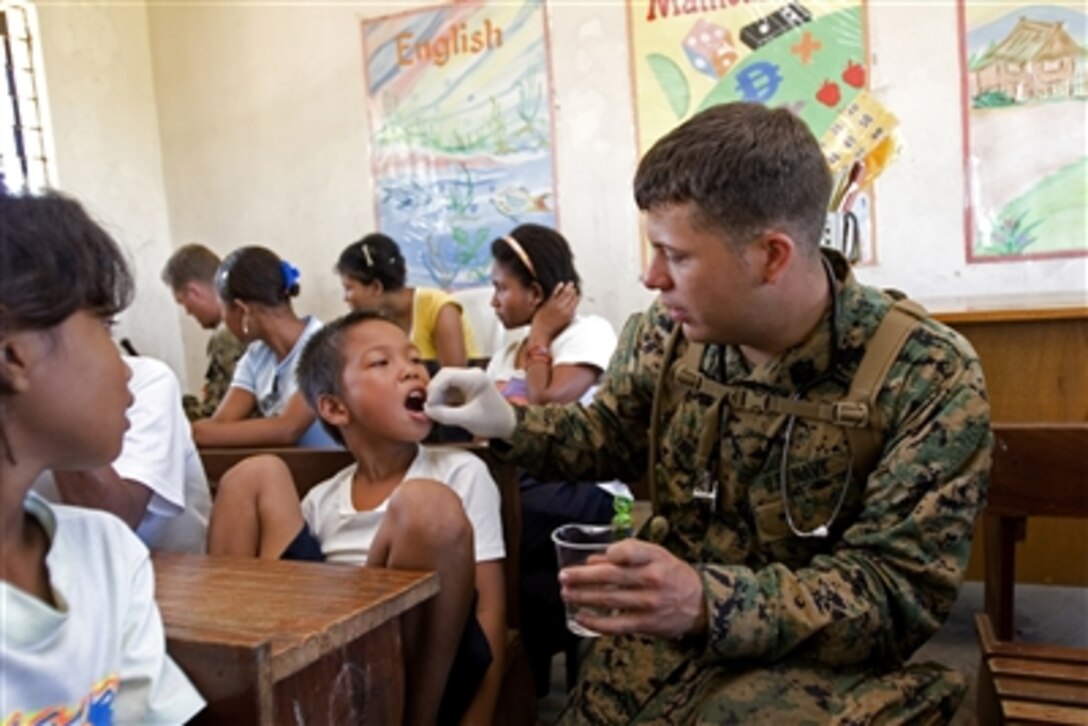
491, 224, 581, 297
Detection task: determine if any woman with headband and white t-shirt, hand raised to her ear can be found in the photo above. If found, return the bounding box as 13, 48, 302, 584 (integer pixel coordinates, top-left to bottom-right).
487, 224, 630, 697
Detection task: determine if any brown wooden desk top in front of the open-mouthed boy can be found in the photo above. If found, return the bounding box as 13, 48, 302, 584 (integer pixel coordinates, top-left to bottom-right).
151, 552, 438, 681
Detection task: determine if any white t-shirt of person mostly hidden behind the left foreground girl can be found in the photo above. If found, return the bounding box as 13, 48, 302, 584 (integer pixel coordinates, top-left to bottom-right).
34, 356, 211, 553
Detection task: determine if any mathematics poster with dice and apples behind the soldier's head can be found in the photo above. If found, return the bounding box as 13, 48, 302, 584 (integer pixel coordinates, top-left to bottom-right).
628, 0, 895, 266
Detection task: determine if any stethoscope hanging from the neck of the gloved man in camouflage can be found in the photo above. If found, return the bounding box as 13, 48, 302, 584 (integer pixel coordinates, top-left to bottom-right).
650, 258, 854, 539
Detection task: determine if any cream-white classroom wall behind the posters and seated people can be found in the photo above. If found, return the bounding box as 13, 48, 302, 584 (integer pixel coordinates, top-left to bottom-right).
29, 0, 1088, 398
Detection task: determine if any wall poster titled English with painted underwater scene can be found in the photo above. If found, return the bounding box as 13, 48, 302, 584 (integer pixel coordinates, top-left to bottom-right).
362, 0, 556, 290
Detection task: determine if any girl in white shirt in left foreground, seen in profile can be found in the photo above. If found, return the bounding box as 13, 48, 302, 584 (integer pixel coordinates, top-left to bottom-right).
0, 187, 203, 724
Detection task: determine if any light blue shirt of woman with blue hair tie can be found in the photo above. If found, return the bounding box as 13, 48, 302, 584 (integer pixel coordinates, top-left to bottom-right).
231, 316, 342, 448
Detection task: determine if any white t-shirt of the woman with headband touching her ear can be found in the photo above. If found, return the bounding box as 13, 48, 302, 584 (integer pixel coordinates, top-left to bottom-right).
487, 316, 616, 404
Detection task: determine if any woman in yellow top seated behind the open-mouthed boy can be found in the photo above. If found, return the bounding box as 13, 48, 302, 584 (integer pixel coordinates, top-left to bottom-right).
336, 233, 479, 366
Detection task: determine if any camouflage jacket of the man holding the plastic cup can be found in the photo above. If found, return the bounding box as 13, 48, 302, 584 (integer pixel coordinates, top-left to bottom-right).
496, 250, 991, 721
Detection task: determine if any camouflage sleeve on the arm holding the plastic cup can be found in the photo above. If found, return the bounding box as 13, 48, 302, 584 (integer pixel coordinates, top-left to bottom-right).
698, 328, 992, 667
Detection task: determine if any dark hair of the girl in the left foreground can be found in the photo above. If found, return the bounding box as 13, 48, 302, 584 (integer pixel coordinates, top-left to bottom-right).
0, 187, 135, 339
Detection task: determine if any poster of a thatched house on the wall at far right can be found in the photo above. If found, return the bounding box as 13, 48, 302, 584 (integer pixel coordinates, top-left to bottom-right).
959, 0, 1088, 262
